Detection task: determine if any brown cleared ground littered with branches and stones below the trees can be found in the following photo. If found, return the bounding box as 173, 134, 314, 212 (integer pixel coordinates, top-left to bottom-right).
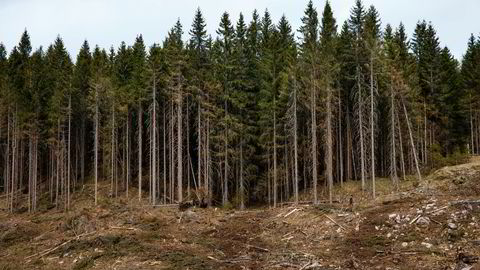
0, 158, 480, 269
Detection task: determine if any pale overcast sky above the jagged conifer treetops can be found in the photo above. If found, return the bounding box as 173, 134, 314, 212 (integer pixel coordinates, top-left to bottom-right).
0, 0, 480, 59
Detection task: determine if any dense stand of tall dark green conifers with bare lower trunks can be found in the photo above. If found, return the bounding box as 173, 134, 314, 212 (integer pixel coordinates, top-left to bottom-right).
0, 0, 480, 212
